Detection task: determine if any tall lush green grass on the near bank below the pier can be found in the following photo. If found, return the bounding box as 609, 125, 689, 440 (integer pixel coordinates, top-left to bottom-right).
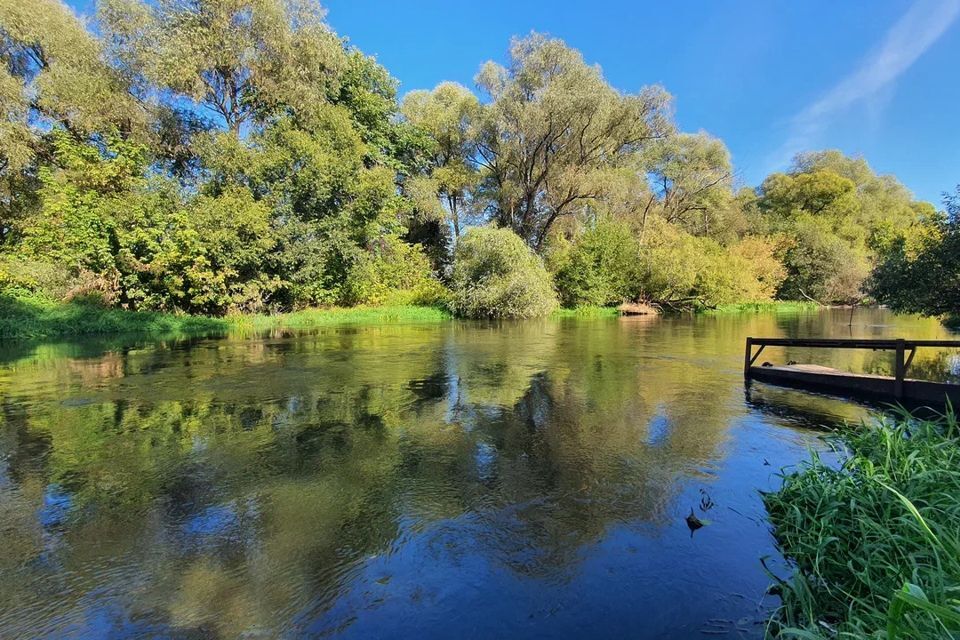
764, 415, 960, 640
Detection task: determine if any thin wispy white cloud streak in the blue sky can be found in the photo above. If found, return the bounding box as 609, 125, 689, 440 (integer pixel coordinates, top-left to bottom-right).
770, 0, 960, 168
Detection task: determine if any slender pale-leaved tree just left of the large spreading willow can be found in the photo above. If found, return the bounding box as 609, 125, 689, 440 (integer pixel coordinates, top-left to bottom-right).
401, 82, 480, 239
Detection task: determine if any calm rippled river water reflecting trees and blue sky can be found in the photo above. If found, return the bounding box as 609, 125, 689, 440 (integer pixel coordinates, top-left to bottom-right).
0, 309, 954, 638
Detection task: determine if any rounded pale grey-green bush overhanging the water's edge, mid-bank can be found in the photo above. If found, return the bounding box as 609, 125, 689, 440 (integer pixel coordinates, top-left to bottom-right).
450, 227, 557, 318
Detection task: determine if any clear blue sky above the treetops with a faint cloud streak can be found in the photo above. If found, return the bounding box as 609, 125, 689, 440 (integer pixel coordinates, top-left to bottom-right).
71, 0, 960, 202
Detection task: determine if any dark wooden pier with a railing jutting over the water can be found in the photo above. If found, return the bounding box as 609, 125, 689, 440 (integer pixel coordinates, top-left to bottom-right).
743, 338, 960, 406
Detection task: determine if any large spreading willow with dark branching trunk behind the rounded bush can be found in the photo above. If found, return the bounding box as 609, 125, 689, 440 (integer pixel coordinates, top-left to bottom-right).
476, 34, 672, 249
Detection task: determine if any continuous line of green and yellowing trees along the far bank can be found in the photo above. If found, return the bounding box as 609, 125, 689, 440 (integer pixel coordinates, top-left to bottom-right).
0, 0, 960, 316
